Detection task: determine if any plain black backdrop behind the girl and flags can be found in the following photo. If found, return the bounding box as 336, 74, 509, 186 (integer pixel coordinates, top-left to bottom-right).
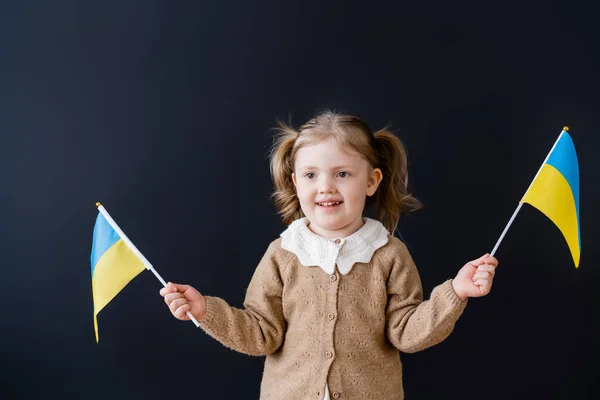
0, 0, 600, 400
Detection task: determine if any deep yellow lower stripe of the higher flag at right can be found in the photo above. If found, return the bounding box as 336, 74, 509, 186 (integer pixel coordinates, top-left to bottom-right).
520, 164, 580, 267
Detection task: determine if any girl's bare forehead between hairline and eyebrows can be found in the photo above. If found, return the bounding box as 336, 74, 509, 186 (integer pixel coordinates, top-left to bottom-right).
294, 139, 368, 169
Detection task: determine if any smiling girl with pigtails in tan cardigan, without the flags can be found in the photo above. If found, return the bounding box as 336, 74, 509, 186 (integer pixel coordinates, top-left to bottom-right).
160, 111, 498, 400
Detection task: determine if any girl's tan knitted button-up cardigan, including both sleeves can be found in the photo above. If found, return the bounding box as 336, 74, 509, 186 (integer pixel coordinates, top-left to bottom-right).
200, 236, 467, 400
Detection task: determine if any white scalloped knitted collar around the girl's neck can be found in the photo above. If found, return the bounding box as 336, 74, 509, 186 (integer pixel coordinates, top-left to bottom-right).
281, 217, 389, 275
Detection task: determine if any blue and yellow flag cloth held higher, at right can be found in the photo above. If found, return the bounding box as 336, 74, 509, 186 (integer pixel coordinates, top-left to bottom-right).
520, 127, 581, 268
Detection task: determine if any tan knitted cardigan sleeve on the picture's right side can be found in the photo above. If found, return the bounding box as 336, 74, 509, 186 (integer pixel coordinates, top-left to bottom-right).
386, 241, 467, 353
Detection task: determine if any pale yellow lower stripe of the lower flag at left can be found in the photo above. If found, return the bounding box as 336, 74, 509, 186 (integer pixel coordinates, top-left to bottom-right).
92, 239, 145, 341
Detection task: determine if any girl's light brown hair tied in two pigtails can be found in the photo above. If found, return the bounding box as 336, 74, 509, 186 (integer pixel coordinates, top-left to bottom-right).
269, 110, 421, 233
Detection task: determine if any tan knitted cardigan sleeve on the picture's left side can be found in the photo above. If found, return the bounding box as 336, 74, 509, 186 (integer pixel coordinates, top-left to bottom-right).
200, 242, 291, 356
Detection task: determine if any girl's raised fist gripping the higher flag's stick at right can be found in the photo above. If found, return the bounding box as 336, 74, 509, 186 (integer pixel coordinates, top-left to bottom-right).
452, 254, 498, 301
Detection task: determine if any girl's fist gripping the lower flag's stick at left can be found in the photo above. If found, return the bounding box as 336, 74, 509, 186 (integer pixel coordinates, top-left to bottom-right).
160, 282, 206, 321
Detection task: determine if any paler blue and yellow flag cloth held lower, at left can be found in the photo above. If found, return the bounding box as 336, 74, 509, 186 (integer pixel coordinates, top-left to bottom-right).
91, 212, 145, 342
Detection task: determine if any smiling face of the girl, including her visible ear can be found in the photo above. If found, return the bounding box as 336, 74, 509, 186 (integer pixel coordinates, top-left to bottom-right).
292, 139, 382, 238
